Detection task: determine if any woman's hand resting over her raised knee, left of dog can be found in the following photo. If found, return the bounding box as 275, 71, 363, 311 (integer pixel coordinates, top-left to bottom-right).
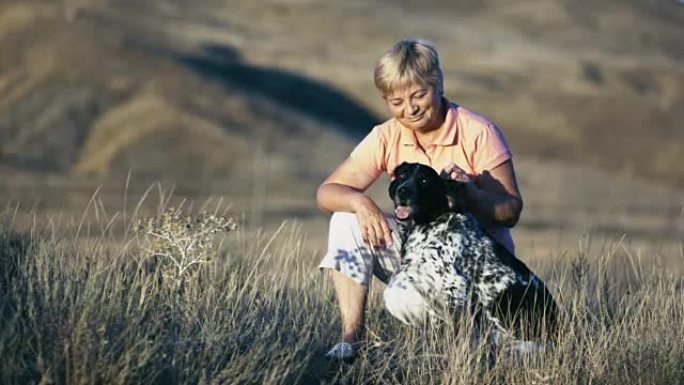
351, 195, 392, 249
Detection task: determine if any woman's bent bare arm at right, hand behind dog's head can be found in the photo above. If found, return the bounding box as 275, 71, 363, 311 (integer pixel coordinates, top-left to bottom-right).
445, 160, 523, 227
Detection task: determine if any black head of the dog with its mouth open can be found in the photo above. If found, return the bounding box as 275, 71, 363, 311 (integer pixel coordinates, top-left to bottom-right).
389, 162, 465, 225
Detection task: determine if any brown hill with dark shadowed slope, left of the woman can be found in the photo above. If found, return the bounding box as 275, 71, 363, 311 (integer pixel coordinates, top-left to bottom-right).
0, 2, 378, 195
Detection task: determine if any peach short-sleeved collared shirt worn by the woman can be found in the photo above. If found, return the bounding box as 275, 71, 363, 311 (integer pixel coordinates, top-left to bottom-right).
350, 103, 514, 252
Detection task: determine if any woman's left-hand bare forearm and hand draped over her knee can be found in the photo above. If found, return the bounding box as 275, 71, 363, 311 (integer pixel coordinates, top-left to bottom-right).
316, 158, 392, 247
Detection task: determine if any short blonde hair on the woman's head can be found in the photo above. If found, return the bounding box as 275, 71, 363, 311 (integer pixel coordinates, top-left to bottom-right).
374, 38, 444, 96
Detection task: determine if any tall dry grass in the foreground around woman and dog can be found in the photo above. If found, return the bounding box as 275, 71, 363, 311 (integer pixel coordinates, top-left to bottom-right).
0, 188, 684, 384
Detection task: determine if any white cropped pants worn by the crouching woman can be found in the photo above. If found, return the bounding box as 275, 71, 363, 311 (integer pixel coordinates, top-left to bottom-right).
318, 212, 446, 324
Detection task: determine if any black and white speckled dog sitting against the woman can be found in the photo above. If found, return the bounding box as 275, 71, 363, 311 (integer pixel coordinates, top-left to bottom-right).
389, 163, 557, 345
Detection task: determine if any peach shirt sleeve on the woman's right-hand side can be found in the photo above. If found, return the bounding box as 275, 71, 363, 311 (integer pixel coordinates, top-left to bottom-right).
471, 123, 513, 175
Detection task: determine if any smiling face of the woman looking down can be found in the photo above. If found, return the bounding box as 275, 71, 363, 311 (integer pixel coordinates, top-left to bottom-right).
385, 84, 443, 132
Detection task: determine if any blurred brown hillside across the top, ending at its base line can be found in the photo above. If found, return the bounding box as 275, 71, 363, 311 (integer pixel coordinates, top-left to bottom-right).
0, 0, 684, 186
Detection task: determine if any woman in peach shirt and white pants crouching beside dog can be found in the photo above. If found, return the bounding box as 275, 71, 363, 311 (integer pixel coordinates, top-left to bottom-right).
317, 39, 523, 359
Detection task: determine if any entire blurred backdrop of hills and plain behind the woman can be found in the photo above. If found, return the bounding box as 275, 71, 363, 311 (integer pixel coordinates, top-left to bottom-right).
0, 0, 684, 260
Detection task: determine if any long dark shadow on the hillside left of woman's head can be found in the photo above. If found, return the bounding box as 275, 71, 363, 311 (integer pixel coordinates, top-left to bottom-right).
174, 44, 379, 138
